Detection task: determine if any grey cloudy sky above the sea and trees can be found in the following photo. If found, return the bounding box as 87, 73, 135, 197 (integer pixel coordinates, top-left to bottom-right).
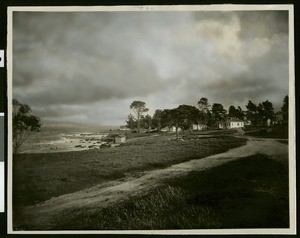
13, 8, 289, 125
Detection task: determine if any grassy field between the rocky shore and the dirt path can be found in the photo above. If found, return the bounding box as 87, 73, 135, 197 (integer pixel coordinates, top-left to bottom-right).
13, 132, 246, 212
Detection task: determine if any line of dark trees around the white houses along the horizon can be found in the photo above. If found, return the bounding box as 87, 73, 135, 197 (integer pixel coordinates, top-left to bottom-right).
126, 96, 288, 136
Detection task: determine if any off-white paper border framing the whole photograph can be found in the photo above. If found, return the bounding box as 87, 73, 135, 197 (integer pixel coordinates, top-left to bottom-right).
7, 4, 296, 235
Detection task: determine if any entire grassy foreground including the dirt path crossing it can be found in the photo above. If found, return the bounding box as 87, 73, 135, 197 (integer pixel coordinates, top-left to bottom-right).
14, 135, 288, 230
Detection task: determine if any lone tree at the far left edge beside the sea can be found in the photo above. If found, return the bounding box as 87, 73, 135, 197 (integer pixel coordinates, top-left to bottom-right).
12, 99, 41, 154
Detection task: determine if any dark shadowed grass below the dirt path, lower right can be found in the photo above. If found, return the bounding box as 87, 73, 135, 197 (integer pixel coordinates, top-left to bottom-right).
52, 154, 289, 230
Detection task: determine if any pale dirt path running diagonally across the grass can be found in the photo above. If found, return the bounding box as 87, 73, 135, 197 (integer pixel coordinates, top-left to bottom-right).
18, 138, 288, 229
